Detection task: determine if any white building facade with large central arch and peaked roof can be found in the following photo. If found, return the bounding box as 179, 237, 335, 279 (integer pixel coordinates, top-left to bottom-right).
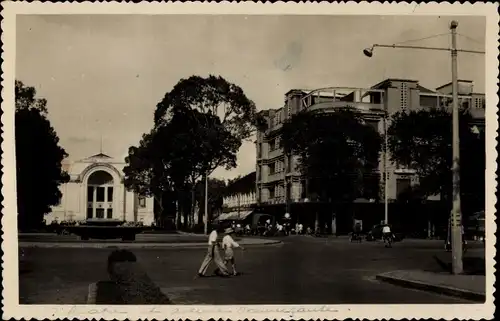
45, 153, 154, 226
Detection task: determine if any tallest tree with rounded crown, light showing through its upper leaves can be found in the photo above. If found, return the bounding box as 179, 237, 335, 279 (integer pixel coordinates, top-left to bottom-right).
148, 75, 265, 226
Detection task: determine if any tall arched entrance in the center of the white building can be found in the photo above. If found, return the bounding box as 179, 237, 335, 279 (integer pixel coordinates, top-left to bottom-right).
87, 170, 114, 219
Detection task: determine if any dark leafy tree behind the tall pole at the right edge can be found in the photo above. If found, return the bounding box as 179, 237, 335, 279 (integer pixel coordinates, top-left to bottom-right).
388, 109, 486, 216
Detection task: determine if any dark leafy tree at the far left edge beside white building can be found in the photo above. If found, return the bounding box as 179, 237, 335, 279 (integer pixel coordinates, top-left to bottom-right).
15, 81, 69, 230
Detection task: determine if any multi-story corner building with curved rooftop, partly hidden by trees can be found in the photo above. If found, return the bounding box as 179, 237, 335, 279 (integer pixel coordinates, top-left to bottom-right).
256, 79, 485, 210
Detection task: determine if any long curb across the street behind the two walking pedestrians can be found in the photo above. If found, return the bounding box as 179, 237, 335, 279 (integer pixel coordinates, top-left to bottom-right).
19, 240, 283, 249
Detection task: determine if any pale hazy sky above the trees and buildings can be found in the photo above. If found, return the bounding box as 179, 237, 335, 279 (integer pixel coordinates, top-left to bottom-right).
16, 15, 486, 178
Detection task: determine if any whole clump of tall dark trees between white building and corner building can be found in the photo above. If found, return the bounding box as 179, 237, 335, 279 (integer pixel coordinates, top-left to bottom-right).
124, 76, 264, 228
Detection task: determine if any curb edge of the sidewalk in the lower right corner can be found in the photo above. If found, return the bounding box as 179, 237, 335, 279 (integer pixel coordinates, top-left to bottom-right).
375, 274, 486, 303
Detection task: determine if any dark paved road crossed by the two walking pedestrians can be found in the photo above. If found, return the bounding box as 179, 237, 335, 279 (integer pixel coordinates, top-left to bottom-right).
20, 236, 481, 304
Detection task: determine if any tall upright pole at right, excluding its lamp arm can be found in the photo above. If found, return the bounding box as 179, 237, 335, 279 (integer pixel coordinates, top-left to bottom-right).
450, 21, 463, 274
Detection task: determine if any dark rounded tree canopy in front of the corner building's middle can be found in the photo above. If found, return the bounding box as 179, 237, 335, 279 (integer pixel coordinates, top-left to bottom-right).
282, 109, 381, 202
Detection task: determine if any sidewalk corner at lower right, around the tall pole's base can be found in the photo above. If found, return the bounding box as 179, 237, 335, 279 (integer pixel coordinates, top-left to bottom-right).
376, 270, 486, 302
